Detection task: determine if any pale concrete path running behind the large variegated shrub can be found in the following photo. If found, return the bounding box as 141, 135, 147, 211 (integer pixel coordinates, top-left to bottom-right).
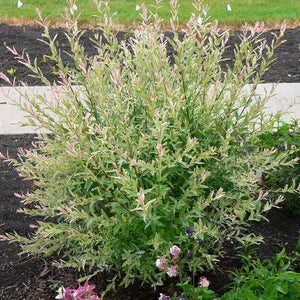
0, 83, 300, 134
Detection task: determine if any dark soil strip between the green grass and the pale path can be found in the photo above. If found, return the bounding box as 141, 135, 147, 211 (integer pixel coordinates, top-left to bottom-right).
0, 24, 300, 86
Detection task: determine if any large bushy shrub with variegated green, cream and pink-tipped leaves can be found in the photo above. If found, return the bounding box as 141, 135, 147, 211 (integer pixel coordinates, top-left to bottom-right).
1, 0, 295, 296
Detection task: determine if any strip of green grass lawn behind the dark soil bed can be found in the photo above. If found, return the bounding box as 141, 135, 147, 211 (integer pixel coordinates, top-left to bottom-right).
0, 0, 300, 26
